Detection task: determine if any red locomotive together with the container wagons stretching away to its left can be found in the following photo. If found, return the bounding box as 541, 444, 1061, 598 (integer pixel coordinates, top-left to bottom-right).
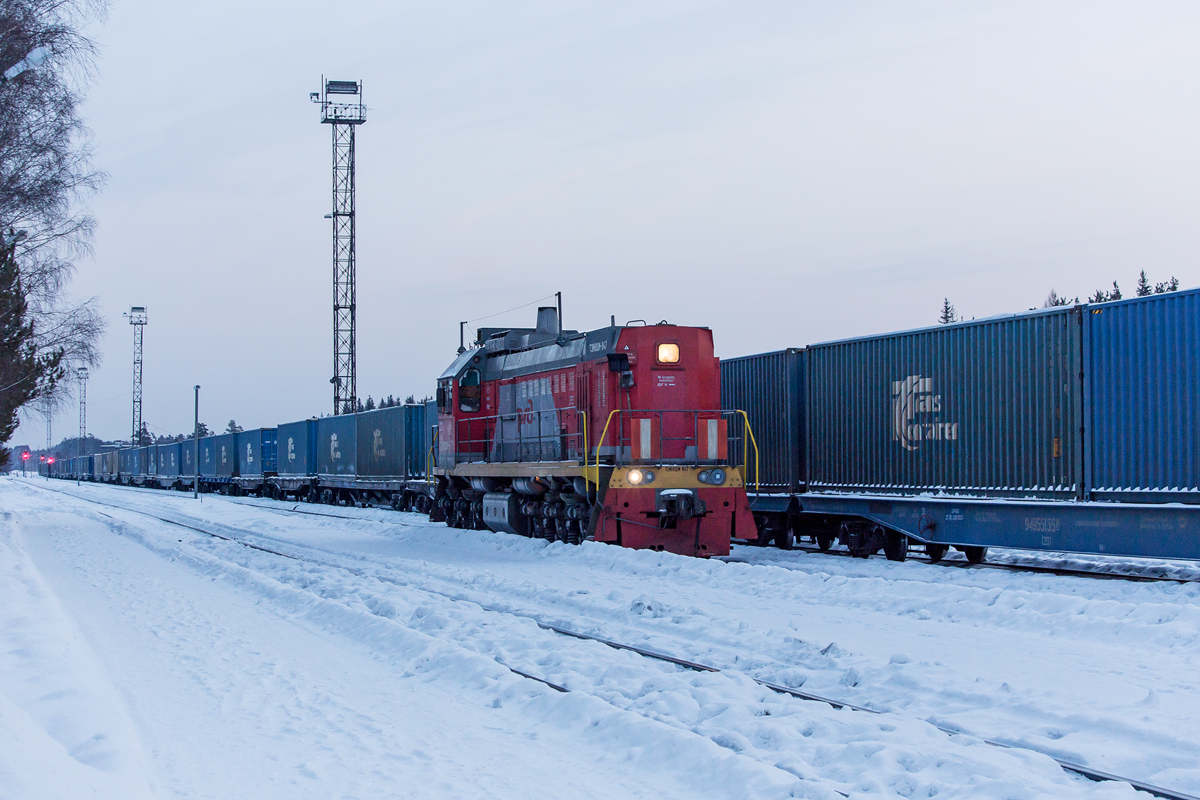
50, 308, 757, 557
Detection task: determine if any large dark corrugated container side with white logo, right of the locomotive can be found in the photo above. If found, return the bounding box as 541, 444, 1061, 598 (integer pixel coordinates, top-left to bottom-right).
806, 307, 1082, 499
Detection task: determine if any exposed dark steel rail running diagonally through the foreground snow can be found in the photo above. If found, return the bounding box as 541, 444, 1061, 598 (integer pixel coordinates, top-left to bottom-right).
30, 483, 1200, 800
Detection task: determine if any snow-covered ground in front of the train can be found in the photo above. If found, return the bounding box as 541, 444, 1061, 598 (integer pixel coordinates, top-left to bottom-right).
0, 477, 1200, 799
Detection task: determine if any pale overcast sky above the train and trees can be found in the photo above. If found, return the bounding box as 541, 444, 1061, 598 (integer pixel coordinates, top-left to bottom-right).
13, 0, 1200, 446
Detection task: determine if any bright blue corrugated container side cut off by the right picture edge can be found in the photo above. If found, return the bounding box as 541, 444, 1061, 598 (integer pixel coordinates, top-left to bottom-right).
1084, 289, 1200, 503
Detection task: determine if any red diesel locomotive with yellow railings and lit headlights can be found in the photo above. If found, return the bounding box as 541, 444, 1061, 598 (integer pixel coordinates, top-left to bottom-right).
432, 308, 757, 557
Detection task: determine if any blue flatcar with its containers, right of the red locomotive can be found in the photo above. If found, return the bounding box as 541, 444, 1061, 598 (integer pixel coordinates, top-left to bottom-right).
721, 290, 1200, 561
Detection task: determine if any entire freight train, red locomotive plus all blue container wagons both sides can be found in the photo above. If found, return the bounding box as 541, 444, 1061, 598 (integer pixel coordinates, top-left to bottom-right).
42, 290, 1200, 563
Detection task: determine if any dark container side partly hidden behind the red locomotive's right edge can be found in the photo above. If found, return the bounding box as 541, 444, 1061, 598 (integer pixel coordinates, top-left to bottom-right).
721, 348, 804, 492
